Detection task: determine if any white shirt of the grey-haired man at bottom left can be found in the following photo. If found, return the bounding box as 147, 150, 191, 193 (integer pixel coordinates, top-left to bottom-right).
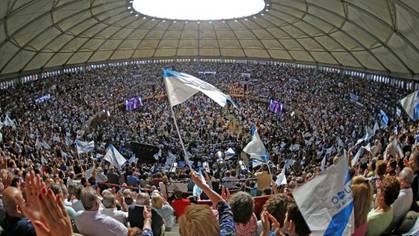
76, 211, 128, 236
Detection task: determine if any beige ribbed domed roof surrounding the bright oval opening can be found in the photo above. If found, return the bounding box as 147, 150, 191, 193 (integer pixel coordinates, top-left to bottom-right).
0, 0, 419, 80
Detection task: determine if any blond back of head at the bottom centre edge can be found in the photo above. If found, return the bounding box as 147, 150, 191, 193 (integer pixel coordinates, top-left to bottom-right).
179, 205, 220, 236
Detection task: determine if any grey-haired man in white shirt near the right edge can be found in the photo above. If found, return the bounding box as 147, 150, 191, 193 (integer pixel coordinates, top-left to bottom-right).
391, 167, 414, 228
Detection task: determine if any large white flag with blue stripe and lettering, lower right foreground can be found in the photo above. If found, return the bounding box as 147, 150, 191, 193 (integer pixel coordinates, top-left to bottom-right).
292, 157, 355, 236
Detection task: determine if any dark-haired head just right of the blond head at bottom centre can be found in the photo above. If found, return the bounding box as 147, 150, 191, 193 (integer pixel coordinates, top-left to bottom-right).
228, 192, 253, 224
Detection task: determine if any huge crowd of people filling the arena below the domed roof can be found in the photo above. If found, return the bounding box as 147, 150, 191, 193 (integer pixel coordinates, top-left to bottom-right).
0, 63, 419, 236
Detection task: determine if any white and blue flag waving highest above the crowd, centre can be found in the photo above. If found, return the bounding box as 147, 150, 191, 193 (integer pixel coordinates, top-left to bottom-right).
163, 69, 236, 107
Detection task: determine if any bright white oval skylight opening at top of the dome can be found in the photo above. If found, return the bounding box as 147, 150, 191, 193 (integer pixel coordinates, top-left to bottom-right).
132, 0, 265, 20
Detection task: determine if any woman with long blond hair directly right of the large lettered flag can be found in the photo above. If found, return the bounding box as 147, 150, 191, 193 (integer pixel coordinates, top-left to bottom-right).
352, 176, 372, 236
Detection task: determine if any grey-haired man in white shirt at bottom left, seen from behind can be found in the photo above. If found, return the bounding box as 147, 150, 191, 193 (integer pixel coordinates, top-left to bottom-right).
76, 187, 128, 236
